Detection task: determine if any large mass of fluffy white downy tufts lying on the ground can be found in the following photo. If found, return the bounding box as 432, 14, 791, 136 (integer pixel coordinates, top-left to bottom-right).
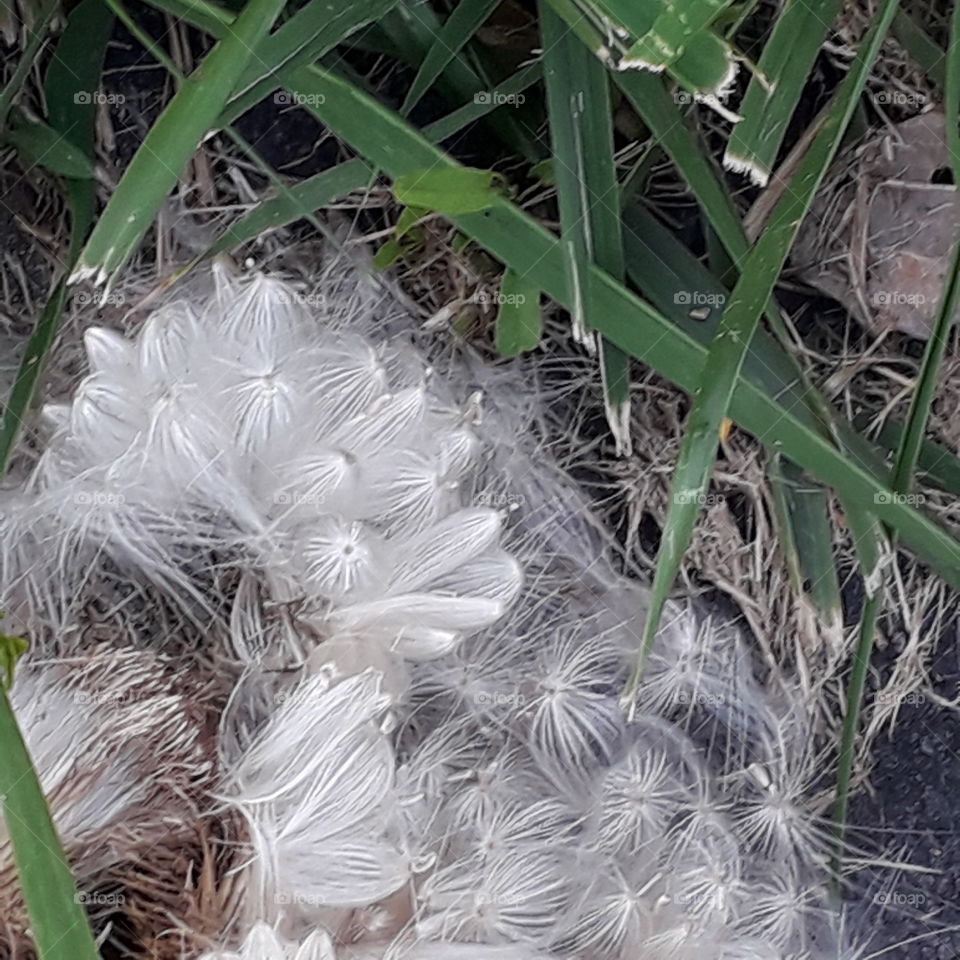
0, 258, 855, 960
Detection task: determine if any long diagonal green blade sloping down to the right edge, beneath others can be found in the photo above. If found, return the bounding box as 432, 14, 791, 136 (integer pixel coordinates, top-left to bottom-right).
291, 67, 960, 585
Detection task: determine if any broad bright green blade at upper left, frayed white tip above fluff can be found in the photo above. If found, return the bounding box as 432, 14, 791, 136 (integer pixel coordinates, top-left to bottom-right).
71, 0, 284, 283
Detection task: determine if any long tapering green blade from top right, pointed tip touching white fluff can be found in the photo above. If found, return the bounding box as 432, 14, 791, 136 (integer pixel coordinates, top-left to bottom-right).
621, 0, 897, 713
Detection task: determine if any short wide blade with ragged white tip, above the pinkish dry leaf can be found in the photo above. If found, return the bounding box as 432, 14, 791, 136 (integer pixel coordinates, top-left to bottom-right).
723, 0, 841, 186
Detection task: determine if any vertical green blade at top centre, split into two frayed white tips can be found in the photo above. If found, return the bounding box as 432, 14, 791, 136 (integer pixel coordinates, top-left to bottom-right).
540, 3, 630, 454
